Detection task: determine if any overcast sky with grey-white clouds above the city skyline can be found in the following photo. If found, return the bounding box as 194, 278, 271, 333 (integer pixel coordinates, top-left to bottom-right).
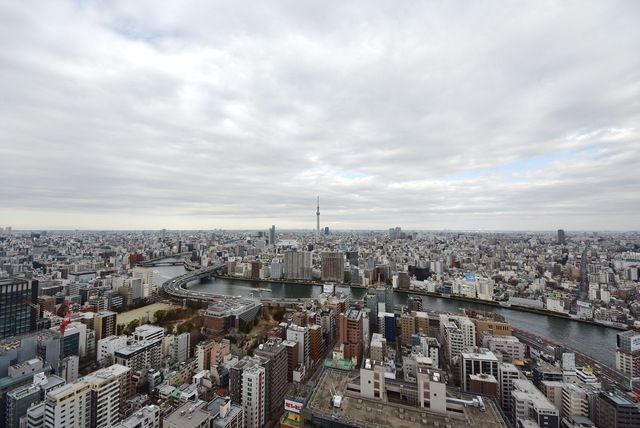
0, 0, 640, 230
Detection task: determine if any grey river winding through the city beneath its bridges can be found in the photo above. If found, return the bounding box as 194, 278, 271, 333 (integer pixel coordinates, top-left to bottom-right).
154, 266, 618, 367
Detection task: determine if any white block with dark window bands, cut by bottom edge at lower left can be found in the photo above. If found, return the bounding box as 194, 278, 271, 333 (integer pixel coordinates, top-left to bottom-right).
44, 382, 91, 428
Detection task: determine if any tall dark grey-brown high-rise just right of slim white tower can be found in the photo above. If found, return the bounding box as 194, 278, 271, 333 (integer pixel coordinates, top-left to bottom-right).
255, 339, 289, 420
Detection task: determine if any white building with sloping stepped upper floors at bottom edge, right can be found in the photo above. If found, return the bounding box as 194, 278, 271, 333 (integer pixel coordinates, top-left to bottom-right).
511, 379, 560, 428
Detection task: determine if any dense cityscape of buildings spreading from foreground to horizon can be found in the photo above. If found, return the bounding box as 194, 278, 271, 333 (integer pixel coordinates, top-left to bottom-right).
0, 227, 640, 428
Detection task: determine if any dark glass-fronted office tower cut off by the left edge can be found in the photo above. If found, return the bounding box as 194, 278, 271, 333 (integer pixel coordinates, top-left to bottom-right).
0, 278, 38, 339
